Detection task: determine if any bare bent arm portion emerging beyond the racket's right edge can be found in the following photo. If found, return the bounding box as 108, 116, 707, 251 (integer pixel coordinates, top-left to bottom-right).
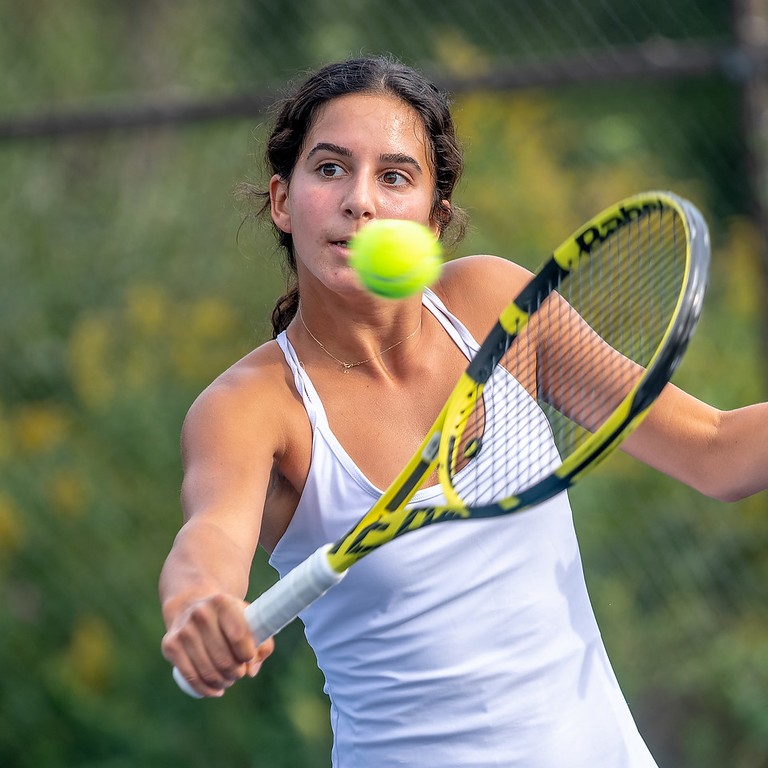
624, 384, 768, 501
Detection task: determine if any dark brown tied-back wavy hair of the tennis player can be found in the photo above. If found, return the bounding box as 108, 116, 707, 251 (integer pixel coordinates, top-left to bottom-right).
244, 56, 466, 337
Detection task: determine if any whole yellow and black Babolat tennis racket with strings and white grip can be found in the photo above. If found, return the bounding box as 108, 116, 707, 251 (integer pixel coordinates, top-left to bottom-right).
174, 192, 709, 696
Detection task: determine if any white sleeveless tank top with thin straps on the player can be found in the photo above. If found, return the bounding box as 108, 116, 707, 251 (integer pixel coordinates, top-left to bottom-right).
270, 290, 656, 768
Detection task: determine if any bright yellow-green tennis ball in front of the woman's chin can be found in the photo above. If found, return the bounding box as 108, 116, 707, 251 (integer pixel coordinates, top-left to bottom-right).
349, 219, 443, 299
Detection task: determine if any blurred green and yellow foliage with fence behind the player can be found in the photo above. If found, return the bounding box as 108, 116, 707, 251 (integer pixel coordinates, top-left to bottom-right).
0, 0, 768, 768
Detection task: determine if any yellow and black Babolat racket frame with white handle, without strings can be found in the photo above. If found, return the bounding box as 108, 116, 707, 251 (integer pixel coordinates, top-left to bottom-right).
173, 191, 710, 698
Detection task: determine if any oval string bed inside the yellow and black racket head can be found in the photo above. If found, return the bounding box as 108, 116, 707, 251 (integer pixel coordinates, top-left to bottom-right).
453, 204, 687, 506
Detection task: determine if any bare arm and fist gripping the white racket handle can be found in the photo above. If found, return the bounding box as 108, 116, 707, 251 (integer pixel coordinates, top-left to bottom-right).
159, 362, 281, 696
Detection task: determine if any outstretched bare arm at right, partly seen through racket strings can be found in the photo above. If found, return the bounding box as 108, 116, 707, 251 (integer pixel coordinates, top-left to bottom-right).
531, 280, 768, 501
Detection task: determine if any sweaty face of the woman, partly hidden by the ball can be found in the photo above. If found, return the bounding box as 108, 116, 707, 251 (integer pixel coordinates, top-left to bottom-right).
270, 93, 438, 300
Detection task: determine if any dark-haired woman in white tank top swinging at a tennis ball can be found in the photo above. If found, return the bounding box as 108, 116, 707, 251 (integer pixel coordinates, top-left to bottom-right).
160, 58, 768, 768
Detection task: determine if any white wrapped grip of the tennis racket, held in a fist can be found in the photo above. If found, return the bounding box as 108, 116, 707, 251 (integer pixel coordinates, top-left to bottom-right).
173, 544, 347, 699
